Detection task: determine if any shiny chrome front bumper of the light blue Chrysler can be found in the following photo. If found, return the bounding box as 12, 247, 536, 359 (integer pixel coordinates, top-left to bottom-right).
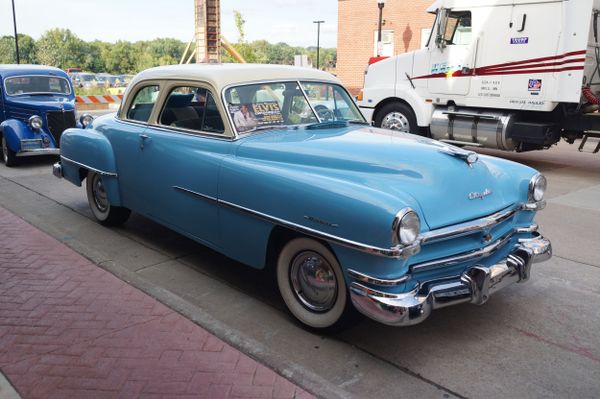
350, 234, 552, 326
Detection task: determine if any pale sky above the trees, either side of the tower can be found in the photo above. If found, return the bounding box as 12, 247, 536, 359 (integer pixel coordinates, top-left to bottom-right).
0, 0, 337, 47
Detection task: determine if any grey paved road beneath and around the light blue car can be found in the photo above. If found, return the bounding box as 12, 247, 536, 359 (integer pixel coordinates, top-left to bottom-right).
0, 138, 600, 398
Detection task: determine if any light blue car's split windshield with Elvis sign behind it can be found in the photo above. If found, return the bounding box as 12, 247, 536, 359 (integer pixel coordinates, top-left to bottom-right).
225, 82, 365, 133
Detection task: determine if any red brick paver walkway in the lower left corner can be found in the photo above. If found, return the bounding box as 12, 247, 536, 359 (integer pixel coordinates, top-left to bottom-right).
0, 208, 312, 399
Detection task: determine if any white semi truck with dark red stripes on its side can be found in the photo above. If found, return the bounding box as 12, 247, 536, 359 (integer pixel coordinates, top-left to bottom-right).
358, 0, 600, 152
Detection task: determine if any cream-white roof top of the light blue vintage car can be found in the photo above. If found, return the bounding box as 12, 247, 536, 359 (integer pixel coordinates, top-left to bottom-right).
130, 64, 340, 90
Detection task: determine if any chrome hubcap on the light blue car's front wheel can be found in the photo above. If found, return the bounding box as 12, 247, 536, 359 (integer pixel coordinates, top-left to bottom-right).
290, 251, 337, 312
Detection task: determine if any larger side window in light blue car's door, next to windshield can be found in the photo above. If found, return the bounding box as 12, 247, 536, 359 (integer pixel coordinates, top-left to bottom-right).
159, 86, 225, 133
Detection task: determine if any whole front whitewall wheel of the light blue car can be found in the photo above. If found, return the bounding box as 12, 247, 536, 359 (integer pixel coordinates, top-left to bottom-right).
277, 238, 354, 330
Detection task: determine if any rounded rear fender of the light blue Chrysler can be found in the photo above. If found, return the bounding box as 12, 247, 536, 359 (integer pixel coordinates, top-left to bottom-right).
60, 128, 121, 206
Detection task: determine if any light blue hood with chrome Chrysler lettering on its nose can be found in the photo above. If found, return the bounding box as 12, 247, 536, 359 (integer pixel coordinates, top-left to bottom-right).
236, 127, 534, 229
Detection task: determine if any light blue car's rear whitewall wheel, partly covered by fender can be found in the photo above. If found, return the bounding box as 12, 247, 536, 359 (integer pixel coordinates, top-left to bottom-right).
86, 171, 131, 226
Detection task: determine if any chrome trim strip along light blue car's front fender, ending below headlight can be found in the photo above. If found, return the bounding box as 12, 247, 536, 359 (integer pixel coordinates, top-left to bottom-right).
217, 199, 421, 258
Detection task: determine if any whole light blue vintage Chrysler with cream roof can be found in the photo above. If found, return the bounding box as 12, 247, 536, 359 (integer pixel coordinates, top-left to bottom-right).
54, 65, 551, 329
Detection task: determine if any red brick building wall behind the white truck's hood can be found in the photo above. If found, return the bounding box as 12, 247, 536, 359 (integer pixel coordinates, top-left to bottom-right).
336, 0, 435, 94
